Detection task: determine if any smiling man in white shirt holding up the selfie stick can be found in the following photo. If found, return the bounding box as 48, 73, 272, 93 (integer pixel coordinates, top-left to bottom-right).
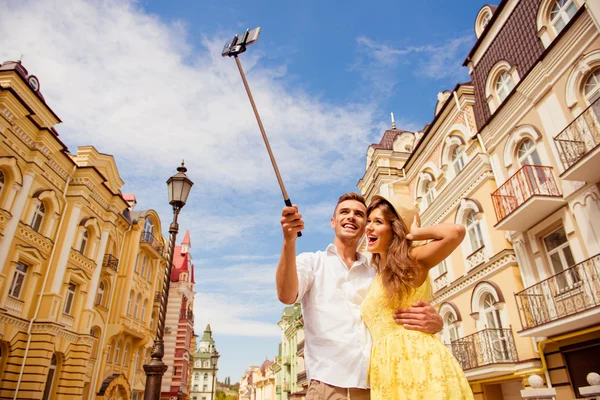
276, 193, 442, 400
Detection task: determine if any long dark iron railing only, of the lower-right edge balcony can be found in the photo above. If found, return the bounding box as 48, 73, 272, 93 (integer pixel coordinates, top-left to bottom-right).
515, 254, 600, 329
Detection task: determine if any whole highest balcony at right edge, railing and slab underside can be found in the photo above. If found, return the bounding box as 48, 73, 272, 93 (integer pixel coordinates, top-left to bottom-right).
554, 98, 600, 182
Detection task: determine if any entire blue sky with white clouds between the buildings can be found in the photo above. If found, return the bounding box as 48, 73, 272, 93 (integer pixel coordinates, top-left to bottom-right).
0, 0, 484, 382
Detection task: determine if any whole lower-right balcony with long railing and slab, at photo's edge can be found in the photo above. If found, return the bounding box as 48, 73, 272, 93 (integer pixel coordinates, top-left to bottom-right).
515, 254, 600, 337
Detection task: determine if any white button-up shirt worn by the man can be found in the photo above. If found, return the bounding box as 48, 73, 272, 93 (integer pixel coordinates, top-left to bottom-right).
296, 244, 375, 388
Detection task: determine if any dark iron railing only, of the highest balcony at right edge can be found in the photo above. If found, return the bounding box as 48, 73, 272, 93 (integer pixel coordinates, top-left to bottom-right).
554, 98, 600, 170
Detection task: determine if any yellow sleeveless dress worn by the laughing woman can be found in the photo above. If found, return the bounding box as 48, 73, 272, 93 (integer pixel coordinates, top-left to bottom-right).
360, 276, 473, 400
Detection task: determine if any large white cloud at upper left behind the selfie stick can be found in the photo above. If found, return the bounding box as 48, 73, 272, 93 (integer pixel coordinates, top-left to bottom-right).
0, 0, 372, 195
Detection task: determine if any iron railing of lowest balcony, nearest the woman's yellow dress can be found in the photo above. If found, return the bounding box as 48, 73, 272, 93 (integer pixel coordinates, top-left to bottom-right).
447, 329, 518, 370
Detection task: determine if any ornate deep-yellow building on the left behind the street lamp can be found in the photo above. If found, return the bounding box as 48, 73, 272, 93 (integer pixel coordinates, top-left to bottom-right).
0, 62, 171, 399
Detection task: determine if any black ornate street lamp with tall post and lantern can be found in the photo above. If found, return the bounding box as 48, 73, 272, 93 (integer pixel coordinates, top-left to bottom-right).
144, 161, 194, 400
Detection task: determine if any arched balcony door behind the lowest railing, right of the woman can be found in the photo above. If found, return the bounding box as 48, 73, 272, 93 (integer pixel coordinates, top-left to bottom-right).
480, 293, 510, 364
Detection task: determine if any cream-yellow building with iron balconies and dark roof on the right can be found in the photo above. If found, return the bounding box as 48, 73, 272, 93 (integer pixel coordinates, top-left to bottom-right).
358, 0, 600, 400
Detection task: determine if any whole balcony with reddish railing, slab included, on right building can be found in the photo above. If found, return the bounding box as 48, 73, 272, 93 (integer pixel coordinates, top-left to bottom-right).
492, 165, 564, 232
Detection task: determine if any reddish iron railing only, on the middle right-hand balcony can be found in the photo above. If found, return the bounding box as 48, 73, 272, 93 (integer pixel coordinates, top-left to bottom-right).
492, 165, 560, 221
